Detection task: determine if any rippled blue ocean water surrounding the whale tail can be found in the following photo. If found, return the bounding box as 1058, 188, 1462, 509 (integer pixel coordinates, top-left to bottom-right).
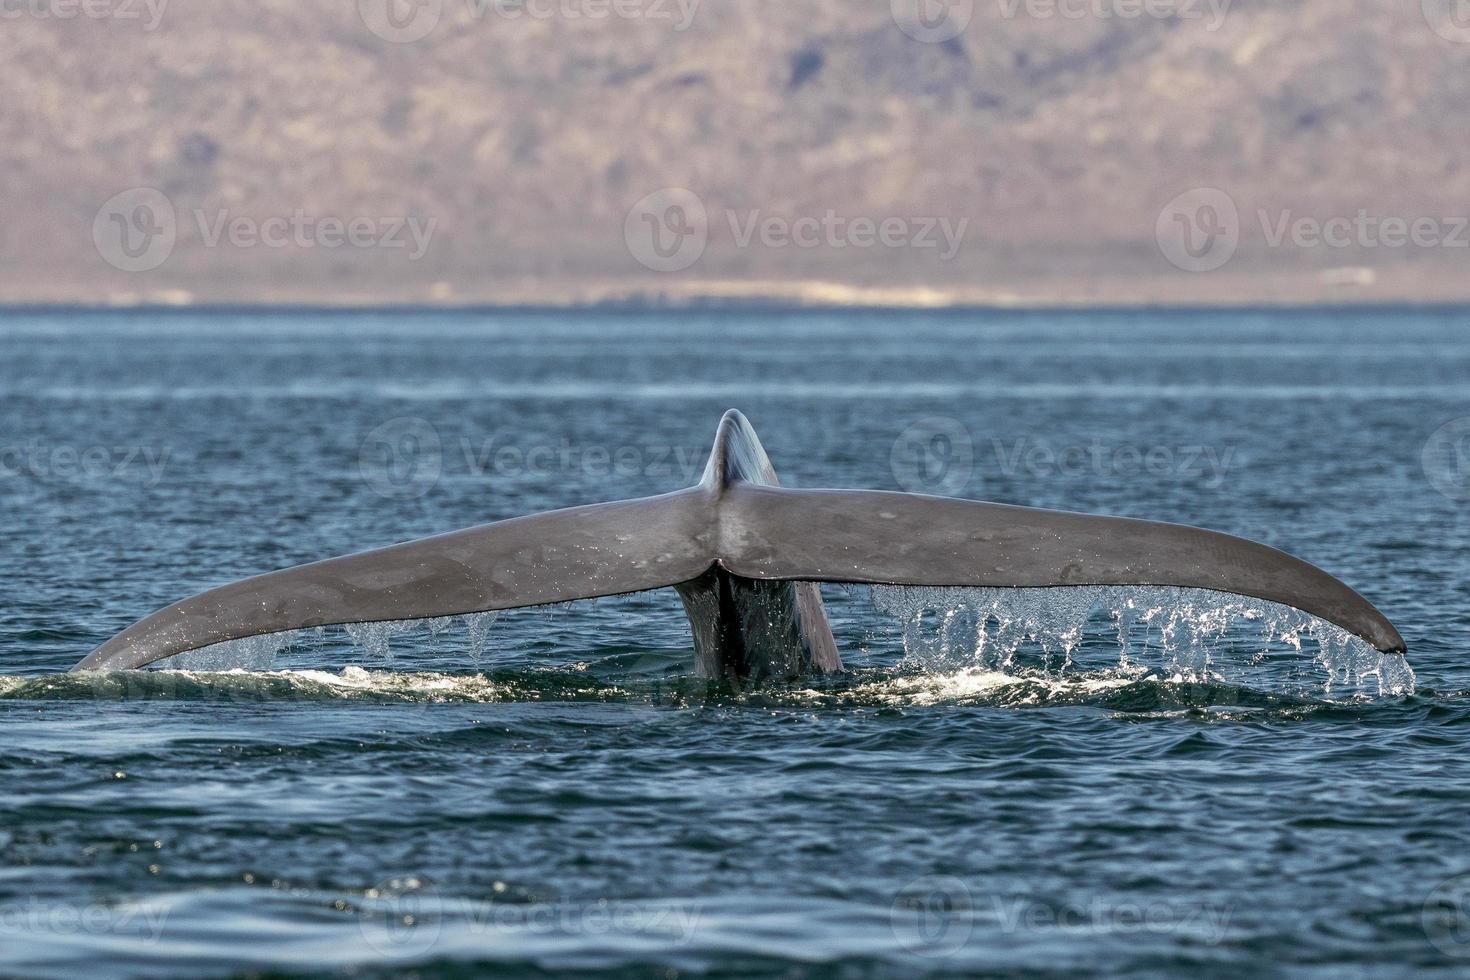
0, 310, 1470, 977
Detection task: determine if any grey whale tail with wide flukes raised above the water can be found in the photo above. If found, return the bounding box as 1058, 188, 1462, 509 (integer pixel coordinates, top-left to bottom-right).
72, 411, 1405, 683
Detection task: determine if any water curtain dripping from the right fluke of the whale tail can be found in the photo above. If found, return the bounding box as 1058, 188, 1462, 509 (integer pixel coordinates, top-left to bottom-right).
870, 586, 1414, 696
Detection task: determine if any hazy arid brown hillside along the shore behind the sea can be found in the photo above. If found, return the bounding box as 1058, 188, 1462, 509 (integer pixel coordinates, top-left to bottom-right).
0, 0, 1470, 304
